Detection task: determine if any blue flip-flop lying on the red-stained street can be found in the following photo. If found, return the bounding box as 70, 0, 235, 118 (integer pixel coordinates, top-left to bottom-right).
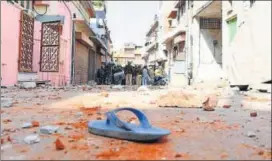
88, 108, 170, 142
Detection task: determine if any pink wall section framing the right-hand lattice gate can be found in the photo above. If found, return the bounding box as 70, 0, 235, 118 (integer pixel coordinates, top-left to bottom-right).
34, 1, 72, 86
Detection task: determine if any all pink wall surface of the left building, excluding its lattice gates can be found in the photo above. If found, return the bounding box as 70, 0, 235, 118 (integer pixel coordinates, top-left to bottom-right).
1, 1, 72, 86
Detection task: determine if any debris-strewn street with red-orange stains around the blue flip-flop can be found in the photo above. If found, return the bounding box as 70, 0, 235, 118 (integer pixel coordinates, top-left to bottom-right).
1, 86, 271, 160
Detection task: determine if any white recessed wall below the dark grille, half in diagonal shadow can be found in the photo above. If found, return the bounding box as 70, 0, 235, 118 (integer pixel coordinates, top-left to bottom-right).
191, 15, 225, 82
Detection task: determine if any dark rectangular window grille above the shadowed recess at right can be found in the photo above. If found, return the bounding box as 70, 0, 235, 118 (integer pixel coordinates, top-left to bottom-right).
200, 18, 221, 29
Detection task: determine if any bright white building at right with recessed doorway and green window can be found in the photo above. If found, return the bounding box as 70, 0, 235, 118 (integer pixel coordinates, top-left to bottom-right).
187, 1, 271, 85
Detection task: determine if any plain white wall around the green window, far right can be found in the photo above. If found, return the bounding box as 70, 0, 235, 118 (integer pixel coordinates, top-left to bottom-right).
223, 1, 271, 84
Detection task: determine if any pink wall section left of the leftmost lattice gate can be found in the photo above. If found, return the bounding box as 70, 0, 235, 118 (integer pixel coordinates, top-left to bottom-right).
1, 1, 20, 86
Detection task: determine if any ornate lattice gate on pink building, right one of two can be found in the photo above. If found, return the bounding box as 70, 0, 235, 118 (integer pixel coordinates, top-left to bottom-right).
40, 21, 60, 72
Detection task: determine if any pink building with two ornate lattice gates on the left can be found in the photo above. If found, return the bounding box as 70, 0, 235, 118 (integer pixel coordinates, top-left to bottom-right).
1, 1, 95, 86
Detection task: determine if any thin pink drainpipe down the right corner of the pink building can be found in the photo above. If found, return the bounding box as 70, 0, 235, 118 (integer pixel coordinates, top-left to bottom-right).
63, 1, 75, 84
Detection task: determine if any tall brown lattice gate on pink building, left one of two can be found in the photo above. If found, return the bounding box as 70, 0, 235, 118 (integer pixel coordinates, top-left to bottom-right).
18, 11, 34, 72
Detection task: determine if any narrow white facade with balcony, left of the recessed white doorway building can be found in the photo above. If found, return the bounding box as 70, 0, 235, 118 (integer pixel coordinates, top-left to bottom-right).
160, 1, 187, 86
